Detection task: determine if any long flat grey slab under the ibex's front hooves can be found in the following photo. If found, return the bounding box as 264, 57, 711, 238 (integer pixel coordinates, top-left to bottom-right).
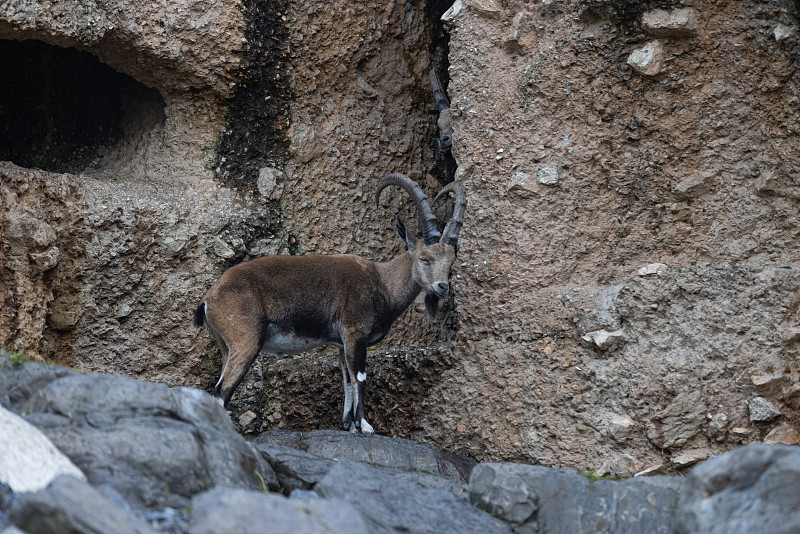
253, 430, 475, 482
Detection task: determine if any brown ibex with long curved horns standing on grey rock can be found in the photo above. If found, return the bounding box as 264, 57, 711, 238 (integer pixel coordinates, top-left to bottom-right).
194, 173, 467, 433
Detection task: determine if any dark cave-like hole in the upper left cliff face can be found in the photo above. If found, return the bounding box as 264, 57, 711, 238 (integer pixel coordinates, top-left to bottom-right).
0, 40, 164, 173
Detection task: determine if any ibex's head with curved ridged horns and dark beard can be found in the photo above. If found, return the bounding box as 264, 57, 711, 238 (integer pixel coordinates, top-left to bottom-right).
375, 174, 467, 316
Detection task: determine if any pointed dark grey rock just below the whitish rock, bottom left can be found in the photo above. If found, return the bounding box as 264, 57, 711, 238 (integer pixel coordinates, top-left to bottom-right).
10, 475, 156, 534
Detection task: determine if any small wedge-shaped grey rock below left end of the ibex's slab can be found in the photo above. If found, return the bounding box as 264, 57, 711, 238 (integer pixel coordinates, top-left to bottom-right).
255, 443, 336, 493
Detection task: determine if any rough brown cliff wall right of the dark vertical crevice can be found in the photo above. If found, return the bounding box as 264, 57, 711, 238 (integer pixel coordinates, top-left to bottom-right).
423, 1, 800, 468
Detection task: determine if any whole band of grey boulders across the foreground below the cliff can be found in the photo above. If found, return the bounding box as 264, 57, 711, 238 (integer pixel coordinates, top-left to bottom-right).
0, 352, 800, 534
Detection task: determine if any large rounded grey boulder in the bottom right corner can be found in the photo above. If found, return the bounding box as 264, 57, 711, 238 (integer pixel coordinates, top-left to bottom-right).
675, 443, 800, 534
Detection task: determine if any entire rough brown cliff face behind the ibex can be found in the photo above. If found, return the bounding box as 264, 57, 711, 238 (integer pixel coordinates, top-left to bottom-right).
0, 0, 800, 475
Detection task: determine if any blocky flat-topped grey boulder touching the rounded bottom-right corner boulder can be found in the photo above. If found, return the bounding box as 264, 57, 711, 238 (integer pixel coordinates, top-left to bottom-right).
468, 463, 680, 534
